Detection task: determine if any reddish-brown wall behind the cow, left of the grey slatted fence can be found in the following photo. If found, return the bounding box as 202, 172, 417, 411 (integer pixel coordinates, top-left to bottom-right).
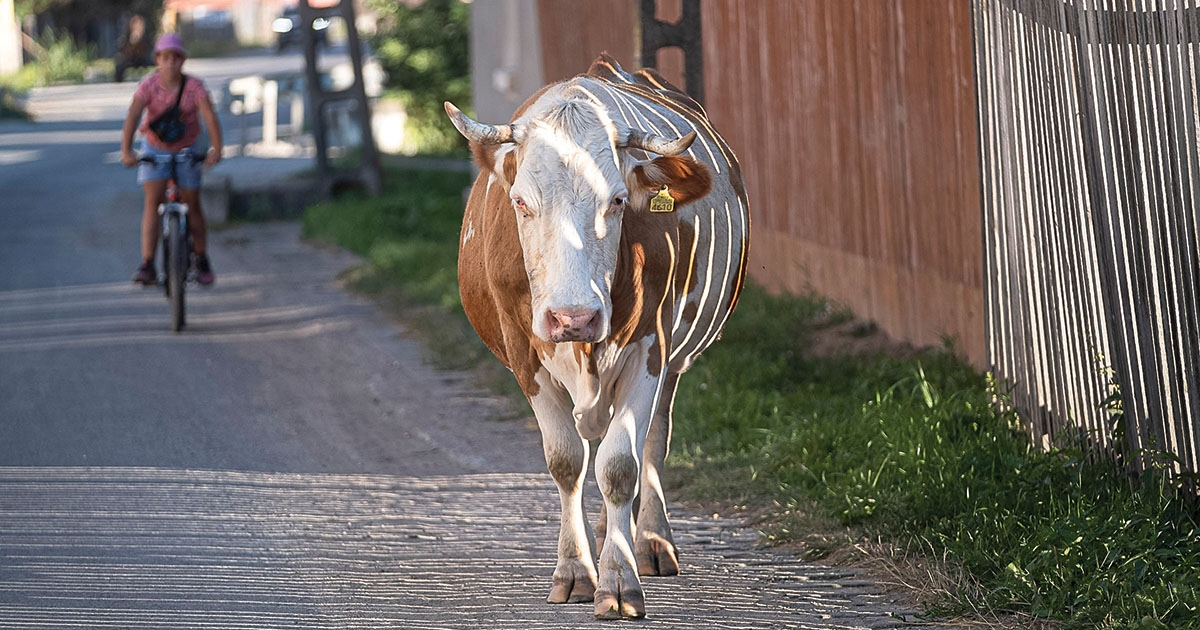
538, 0, 985, 366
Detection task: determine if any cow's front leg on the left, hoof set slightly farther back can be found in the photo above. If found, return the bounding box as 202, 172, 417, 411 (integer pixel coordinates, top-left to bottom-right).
529, 386, 596, 604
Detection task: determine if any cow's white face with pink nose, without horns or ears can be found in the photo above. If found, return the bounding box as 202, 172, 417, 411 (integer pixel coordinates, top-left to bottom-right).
509, 111, 629, 342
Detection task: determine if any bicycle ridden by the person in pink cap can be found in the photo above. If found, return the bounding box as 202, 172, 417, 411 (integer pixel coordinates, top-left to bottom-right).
138, 149, 204, 332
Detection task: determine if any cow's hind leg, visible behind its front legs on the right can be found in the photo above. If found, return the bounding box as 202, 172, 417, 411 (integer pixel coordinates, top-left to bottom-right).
634, 373, 679, 575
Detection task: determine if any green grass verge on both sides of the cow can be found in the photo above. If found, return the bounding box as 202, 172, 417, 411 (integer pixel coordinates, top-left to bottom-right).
305, 163, 1200, 628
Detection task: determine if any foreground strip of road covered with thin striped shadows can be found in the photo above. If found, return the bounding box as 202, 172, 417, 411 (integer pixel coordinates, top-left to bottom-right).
0, 468, 955, 630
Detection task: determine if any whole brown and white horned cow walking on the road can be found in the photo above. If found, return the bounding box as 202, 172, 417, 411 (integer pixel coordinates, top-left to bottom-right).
445, 55, 750, 618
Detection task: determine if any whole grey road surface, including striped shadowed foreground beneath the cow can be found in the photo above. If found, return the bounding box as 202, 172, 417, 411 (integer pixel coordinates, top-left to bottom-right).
0, 50, 940, 629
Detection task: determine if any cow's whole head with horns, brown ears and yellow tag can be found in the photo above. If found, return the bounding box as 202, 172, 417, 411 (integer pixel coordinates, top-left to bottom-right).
445, 95, 710, 343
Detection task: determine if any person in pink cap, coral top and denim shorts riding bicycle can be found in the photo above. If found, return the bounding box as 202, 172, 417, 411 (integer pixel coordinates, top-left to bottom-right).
121, 32, 223, 284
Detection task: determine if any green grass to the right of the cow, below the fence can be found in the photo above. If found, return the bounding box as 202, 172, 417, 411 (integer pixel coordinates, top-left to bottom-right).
674, 290, 1200, 628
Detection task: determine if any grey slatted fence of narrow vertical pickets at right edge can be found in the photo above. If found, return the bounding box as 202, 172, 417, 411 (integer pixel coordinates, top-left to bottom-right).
973, 0, 1200, 472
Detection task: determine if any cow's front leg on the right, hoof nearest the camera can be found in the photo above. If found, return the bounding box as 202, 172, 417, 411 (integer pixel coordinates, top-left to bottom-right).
595, 373, 658, 619
